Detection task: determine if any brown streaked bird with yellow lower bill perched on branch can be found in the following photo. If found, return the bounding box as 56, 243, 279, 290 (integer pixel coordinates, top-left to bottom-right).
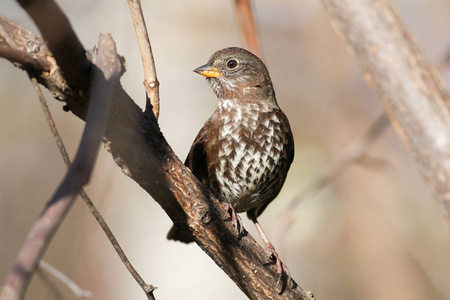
167, 48, 294, 277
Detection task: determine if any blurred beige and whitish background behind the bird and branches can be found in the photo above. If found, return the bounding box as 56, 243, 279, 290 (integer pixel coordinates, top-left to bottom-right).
0, 0, 450, 300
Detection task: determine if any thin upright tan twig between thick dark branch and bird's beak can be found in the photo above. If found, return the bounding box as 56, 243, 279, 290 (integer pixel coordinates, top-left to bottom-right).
128, 0, 160, 119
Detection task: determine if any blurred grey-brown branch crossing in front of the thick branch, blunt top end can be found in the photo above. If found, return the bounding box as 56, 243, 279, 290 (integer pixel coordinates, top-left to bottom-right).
2, 36, 121, 299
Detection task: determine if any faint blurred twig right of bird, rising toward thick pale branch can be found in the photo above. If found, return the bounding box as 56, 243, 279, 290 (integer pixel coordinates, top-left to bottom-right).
275, 113, 390, 244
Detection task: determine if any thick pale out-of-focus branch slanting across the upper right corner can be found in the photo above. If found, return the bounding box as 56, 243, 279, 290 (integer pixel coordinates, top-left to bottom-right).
322, 0, 450, 218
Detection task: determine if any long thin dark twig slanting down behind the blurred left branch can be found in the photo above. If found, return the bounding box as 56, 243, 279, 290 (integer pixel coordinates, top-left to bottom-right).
31, 73, 156, 299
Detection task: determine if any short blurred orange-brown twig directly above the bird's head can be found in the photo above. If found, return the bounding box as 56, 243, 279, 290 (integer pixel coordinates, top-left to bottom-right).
234, 0, 262, 59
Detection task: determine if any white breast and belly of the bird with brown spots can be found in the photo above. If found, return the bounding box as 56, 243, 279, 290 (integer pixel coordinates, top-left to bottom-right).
214, 100, 286, 212
